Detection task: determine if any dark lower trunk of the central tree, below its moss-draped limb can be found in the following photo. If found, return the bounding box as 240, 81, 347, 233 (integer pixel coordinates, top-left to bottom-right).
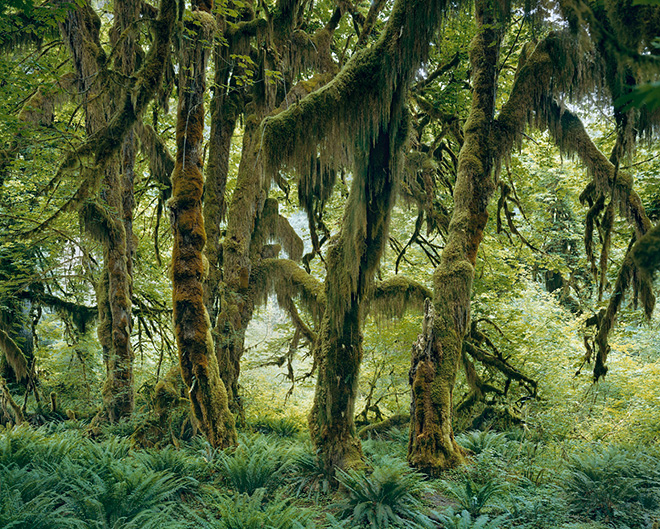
309, 126, 401, 472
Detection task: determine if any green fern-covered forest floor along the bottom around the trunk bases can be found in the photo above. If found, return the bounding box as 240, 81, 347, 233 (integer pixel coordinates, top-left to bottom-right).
0, 419, 660, 529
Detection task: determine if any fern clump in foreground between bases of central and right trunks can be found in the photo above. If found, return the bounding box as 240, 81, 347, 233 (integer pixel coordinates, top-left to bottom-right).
336, 458, 434, 529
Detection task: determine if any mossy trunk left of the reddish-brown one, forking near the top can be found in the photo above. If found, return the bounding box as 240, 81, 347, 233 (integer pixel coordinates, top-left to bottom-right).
61, 0, 140, 422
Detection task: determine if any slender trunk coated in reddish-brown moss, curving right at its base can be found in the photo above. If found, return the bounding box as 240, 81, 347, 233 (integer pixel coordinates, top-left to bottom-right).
169, 2, 236, 447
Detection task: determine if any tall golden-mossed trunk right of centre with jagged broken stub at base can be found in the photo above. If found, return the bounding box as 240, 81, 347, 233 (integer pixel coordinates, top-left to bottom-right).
408, 0, 501, 474
